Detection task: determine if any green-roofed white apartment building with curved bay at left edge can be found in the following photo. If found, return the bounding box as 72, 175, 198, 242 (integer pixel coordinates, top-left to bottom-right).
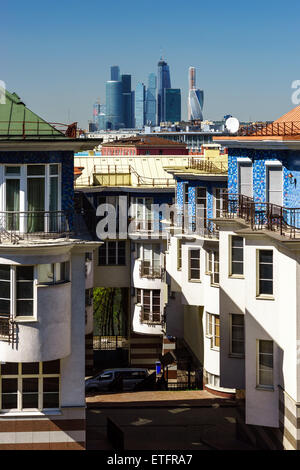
0, 92, 98, 450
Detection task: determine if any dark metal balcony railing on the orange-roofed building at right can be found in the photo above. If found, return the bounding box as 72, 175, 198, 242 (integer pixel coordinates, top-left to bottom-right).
223, 193, 300, 238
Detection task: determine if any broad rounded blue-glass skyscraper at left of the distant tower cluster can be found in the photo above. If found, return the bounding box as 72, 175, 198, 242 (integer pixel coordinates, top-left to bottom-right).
106, 80, 124, 130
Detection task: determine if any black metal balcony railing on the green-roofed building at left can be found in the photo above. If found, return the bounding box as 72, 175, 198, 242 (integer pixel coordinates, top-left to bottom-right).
0, 211, 71, 242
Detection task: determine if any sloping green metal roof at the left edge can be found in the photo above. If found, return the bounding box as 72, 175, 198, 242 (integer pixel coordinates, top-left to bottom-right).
0, 90, 68, 140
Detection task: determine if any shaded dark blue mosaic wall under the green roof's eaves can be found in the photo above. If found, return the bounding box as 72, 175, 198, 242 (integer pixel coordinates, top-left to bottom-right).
0, 151, 74, 211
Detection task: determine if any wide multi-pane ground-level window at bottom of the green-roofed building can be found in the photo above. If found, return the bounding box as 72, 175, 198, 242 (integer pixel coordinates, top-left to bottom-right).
0, 360, 60, 411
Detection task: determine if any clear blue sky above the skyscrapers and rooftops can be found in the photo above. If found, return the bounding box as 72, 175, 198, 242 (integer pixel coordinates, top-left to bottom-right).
0, 0, 300, 127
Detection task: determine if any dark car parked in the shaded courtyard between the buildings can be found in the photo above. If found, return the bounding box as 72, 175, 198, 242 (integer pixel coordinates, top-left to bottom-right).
85, 368, 149, 393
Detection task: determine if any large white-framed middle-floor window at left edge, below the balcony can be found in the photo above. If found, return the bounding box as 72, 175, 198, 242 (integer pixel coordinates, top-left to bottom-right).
0, 264, 34, 318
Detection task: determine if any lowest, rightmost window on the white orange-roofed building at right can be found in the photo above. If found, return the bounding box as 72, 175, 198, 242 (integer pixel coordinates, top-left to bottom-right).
257, 340, 273, 389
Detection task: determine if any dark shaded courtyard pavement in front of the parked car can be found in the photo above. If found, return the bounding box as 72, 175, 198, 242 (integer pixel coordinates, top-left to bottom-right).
87, 391, 252, 450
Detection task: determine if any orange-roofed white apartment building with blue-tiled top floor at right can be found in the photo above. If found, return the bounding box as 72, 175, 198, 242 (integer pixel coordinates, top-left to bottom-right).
214, 107, 300, 449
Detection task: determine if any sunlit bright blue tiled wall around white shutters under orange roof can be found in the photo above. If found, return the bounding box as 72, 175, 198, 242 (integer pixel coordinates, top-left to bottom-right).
228, 149, 300, 208
